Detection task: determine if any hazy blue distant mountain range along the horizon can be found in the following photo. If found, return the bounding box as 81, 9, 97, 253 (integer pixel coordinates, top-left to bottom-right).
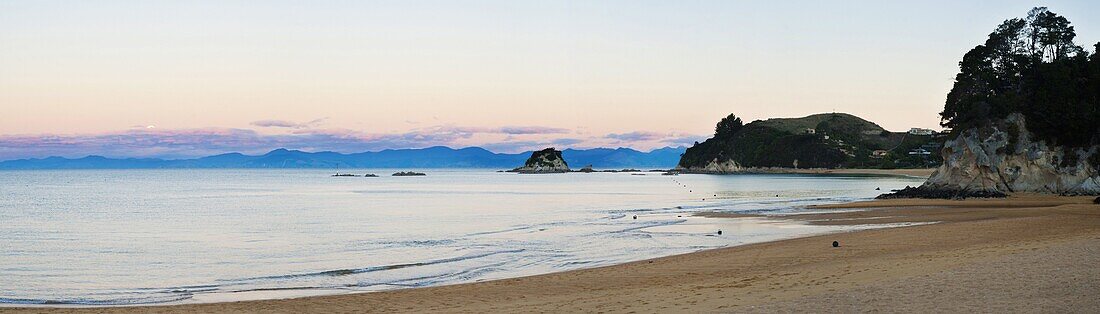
0, 147, 685, 170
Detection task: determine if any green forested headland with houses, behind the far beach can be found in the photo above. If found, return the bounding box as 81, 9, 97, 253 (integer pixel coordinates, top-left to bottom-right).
679, 113, 941, 172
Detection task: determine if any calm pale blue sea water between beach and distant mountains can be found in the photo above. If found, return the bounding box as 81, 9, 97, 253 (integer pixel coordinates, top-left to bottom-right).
0, 170, 921, 305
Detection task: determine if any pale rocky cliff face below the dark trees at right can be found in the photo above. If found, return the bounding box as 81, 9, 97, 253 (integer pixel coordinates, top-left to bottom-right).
920, 113, 1100, 195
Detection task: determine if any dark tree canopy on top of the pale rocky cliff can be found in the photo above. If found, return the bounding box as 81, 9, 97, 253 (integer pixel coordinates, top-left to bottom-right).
941, 8, 1100, 147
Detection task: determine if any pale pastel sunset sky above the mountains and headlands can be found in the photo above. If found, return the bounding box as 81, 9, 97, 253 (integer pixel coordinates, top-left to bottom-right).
0, 0, 1100, 160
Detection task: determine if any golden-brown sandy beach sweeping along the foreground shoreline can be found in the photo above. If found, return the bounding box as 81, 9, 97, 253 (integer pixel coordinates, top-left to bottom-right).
0, 195, 1100, 313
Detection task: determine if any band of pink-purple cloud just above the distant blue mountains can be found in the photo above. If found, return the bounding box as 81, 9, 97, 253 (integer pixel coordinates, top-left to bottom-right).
0, 126, 704, 160
